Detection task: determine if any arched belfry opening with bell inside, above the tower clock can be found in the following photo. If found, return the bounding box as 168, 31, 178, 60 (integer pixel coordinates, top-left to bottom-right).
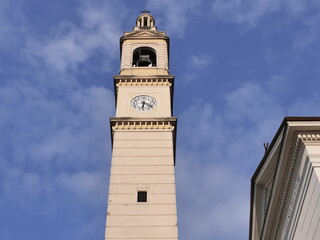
132, 47, 157, 67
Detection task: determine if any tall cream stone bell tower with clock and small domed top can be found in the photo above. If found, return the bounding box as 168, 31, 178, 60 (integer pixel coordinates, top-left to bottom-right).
105, 11, 178, 240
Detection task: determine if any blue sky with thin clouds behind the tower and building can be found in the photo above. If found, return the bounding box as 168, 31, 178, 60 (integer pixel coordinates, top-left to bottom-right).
0, 0, 320, 240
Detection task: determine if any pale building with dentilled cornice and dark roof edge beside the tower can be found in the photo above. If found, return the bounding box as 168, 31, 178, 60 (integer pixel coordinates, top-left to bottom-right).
249, 117, 320, 240
